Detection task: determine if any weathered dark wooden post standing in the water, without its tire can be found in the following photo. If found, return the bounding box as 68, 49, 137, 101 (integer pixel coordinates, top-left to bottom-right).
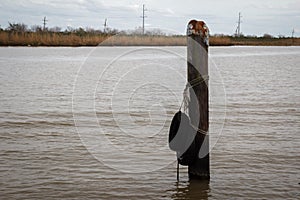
187, 20, 210, 180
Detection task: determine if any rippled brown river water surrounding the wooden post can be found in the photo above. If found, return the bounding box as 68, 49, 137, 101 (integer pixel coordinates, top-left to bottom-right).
0, 47, 300, 199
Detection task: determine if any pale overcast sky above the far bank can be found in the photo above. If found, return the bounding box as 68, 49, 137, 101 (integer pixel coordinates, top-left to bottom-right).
0, 0, 300, 37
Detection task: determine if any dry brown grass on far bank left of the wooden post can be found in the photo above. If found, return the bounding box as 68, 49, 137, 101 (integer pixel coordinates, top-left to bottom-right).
0, 31, 186, 46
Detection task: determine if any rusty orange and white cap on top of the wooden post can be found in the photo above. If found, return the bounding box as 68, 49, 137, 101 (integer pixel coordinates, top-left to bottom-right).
186, 19, 209, 45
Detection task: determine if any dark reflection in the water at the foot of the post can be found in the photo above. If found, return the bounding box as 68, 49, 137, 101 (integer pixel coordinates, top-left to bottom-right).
172, 180, 210, 200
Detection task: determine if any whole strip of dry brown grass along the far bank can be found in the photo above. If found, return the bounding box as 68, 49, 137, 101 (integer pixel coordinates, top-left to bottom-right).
0, 31, 300, 46
